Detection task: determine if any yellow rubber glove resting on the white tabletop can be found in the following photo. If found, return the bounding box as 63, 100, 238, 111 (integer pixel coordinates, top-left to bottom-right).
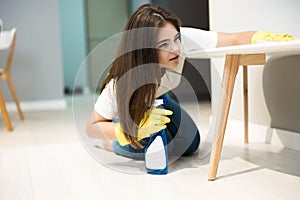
251, 31, 297, 44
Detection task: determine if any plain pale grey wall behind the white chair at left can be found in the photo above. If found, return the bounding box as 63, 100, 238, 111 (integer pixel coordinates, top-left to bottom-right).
0, 0, 65, 109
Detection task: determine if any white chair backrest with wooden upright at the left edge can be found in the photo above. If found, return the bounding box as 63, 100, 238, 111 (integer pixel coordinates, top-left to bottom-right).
0, 28, 16, 71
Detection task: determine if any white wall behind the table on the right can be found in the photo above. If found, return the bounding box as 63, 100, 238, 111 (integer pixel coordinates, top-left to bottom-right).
209, 0, 300, 148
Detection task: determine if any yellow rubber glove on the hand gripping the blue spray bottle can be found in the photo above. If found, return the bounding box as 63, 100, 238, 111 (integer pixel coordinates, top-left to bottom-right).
115, 108, 173, 146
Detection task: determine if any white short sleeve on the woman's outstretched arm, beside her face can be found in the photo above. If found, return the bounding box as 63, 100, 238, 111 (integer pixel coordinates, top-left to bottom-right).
180, 27, 218, 54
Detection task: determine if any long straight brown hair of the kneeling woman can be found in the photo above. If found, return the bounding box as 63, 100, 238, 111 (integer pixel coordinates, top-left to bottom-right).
101, 4, 181, 148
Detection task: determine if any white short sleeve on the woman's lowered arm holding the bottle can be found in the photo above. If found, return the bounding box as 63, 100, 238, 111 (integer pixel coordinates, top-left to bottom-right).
94, 80, 117, 119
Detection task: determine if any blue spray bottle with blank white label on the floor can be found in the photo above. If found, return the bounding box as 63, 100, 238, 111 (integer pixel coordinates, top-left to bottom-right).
145, 99, 168, 175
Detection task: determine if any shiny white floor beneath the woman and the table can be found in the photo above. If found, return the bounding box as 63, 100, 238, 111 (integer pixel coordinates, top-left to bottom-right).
0, 97, 300, 200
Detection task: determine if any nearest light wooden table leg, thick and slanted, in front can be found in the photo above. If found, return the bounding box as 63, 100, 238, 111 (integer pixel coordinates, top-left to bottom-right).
208, 55, 240, 180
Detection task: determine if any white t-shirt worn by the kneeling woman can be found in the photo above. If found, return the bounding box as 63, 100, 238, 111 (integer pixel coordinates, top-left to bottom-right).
94, 27, 218, 120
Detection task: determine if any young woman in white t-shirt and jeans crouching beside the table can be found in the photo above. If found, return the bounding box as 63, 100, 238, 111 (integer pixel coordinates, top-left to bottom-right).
86, 4, 298, 159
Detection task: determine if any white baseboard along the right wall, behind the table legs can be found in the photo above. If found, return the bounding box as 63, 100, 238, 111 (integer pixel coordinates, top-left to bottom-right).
225, 119, 300, 151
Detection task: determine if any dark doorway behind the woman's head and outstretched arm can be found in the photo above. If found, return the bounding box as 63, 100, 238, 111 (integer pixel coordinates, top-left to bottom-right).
152, 0, 211, 101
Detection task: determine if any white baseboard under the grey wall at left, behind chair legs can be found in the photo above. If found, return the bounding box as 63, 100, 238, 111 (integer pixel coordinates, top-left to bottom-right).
6, 99, 67, 112
